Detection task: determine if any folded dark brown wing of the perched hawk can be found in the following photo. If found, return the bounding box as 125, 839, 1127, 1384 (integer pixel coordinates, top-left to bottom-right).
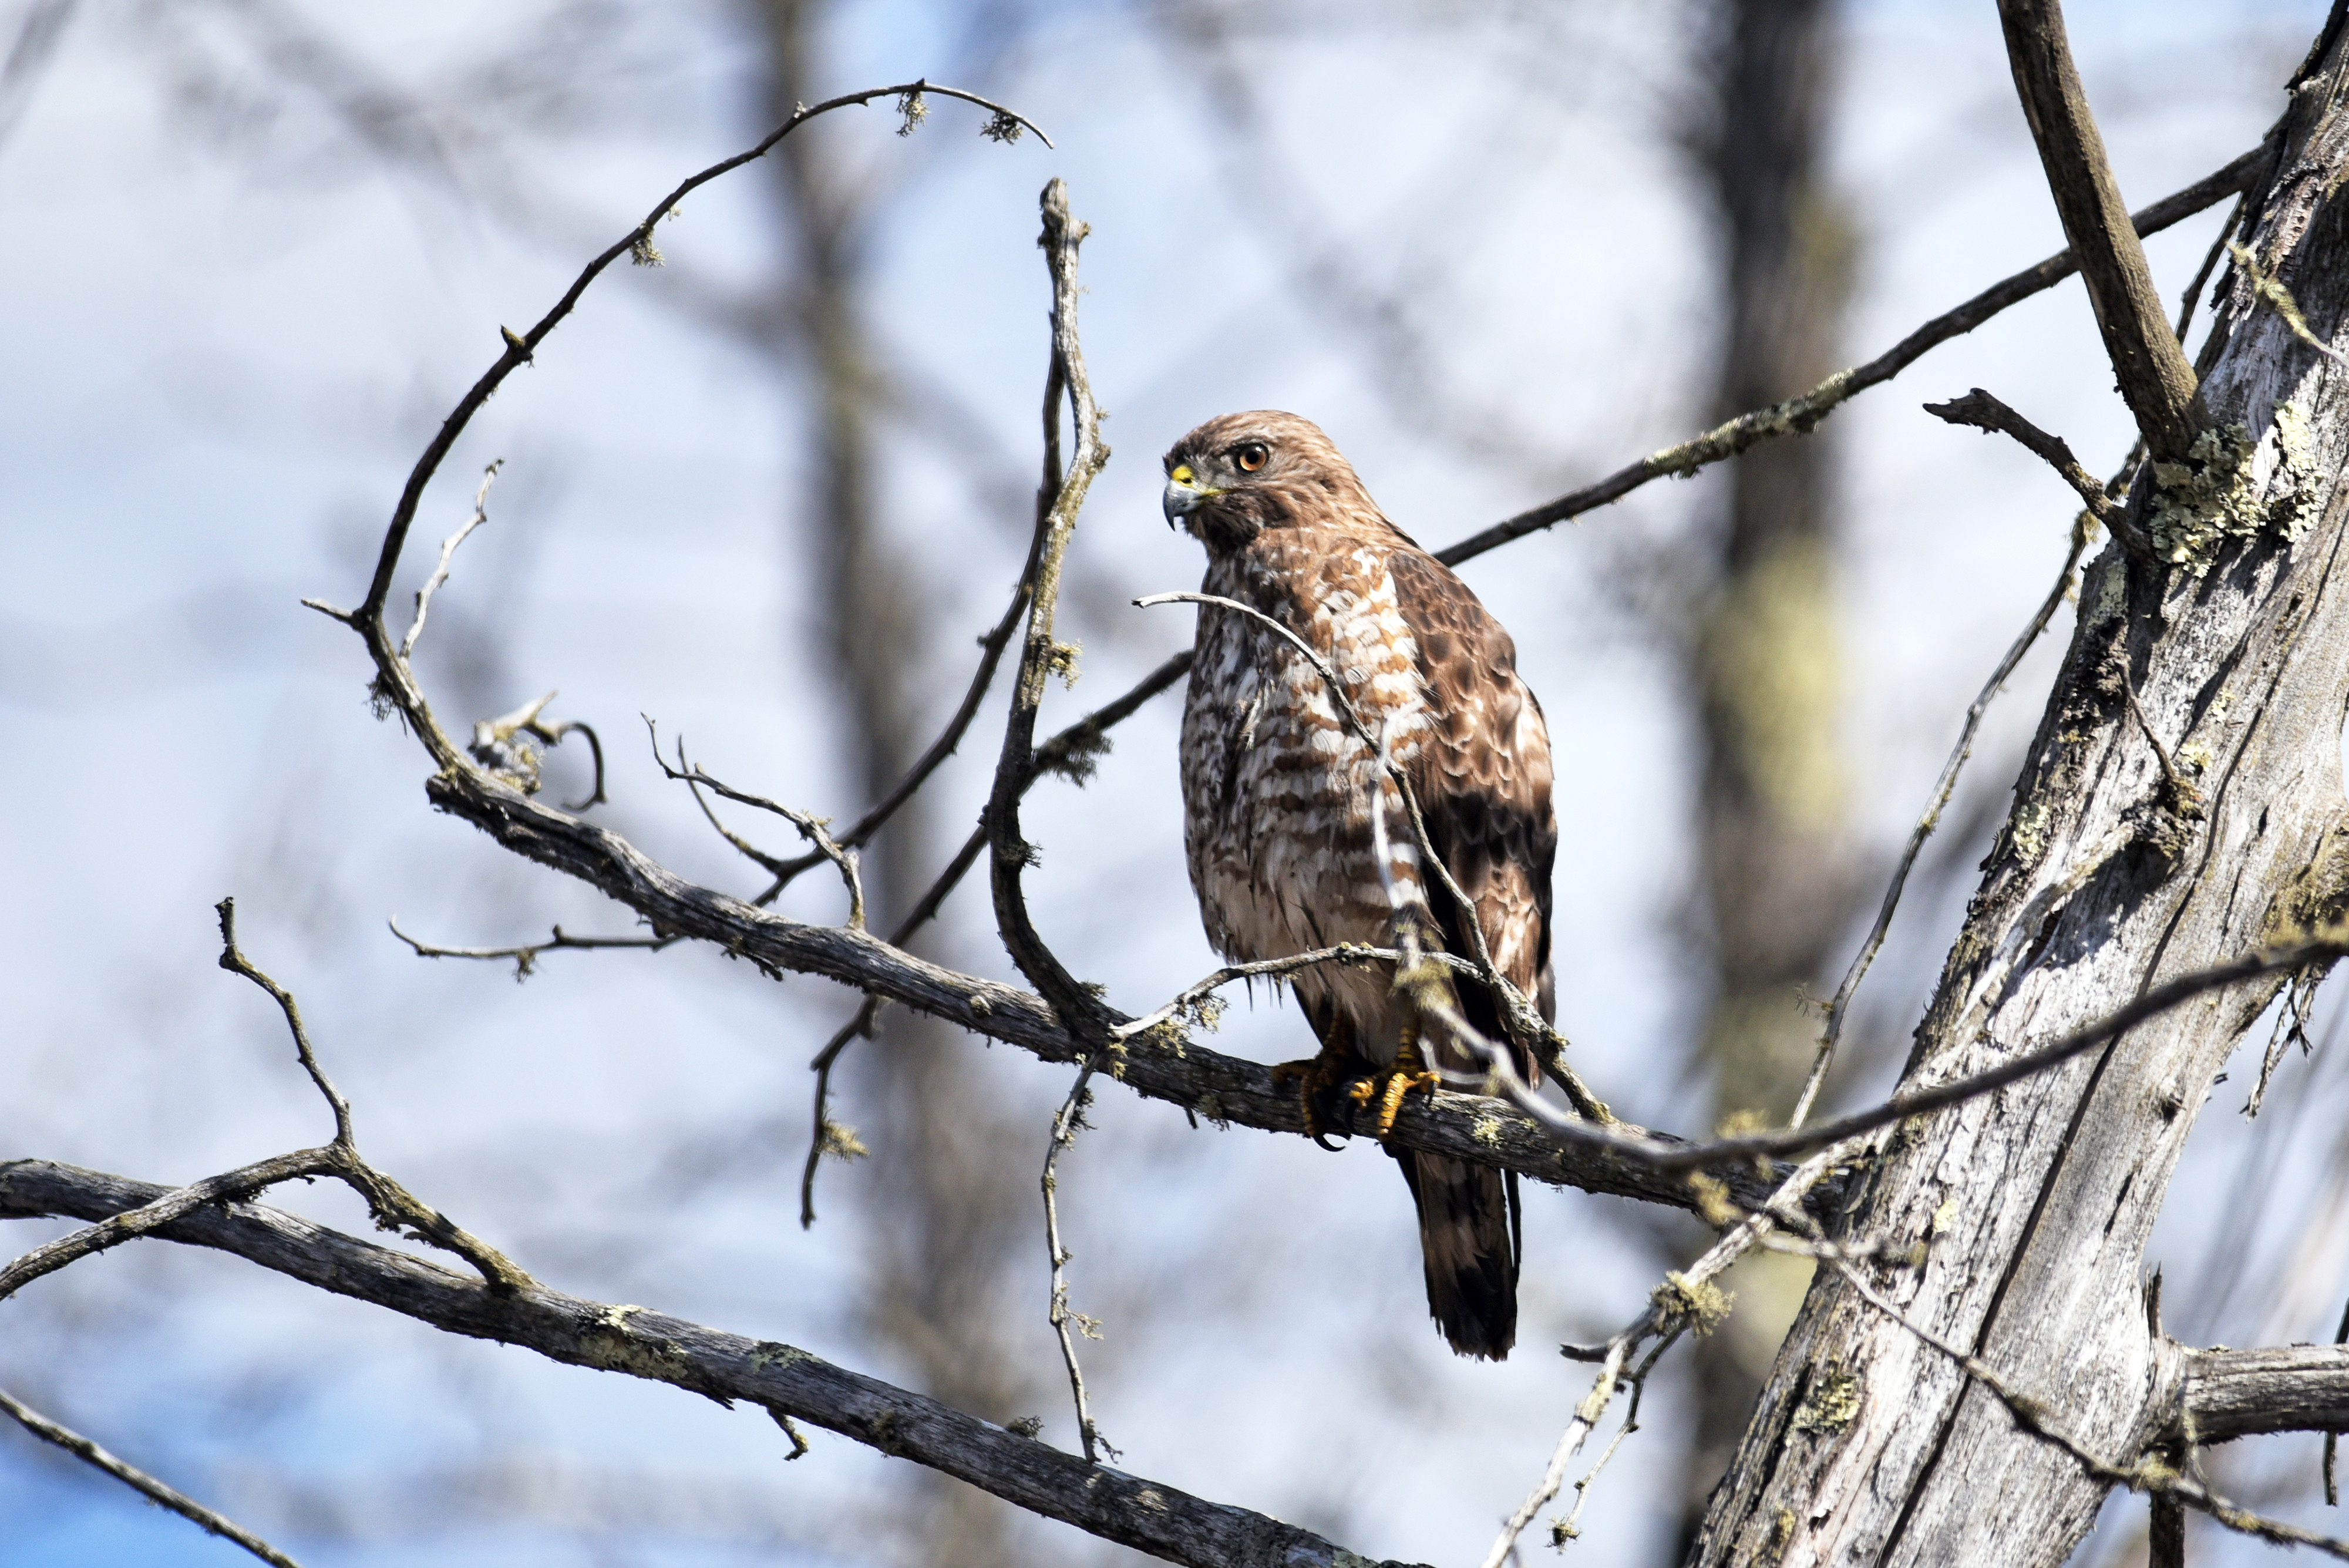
1388, 549, 1557, 1080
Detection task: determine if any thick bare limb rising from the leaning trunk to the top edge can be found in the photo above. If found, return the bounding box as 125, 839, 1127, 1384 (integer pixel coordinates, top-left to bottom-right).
1999, 0, 2203, 462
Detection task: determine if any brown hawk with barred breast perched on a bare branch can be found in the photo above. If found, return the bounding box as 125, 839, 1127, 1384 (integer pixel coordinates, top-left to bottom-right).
1165, 410, 1557, 1361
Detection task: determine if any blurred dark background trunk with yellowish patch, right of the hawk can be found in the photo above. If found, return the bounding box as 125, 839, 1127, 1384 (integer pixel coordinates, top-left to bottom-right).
1680, 0, 1858, 1545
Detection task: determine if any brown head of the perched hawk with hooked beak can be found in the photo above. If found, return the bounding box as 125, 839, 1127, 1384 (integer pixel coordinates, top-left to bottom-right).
1165, 408, 1386, 551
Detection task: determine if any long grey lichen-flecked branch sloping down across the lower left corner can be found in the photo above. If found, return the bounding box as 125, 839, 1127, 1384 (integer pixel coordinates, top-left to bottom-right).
0, 1160, 1402, 1568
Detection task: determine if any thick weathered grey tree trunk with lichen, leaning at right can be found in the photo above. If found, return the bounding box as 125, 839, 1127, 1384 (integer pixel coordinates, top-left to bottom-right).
1694, 18, 2349, 1566
